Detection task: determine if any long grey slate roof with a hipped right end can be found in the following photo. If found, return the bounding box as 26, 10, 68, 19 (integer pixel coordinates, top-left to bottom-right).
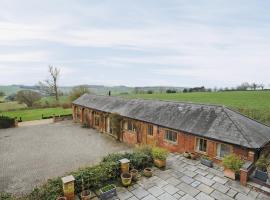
73, 94, 270, 149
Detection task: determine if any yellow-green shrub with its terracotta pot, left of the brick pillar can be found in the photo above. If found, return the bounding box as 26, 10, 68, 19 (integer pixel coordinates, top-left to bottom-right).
222, 154, 244, 180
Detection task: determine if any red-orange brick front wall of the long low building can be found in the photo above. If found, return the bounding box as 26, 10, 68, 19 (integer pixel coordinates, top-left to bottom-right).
73, 106, 255, 162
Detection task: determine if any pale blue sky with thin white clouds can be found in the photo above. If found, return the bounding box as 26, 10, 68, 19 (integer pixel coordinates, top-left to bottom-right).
0, 0, 270, 87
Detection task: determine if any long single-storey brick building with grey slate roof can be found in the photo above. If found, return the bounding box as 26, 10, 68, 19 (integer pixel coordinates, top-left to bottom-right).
73, 94, 270, 162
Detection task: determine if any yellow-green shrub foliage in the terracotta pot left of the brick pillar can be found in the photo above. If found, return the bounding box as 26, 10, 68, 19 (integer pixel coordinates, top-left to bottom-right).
222, 154, 244, 174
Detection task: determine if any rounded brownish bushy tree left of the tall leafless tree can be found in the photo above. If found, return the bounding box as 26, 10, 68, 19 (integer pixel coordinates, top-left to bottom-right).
16, 90, 41, 107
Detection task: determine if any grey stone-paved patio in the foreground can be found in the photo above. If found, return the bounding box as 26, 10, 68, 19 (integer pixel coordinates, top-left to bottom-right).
114, 154, 270, 200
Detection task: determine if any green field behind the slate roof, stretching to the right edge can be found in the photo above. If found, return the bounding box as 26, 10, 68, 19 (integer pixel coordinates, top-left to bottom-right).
119, 91, 270, 124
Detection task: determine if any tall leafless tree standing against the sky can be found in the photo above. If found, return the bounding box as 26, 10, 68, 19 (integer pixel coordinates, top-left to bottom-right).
39, 65, 60, 101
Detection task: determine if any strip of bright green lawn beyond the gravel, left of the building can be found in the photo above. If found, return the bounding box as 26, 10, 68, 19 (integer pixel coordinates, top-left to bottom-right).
0, 108, 72, 121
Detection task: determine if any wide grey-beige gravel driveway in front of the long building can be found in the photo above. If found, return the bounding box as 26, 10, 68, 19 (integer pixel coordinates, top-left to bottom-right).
0, 121, 129, 194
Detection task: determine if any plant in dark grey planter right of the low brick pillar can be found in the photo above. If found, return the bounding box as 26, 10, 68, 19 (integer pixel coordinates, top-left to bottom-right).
255, 155, 270, 182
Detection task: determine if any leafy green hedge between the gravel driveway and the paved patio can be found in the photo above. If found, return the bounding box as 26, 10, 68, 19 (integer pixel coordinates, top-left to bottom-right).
1, 148, 153, 200
